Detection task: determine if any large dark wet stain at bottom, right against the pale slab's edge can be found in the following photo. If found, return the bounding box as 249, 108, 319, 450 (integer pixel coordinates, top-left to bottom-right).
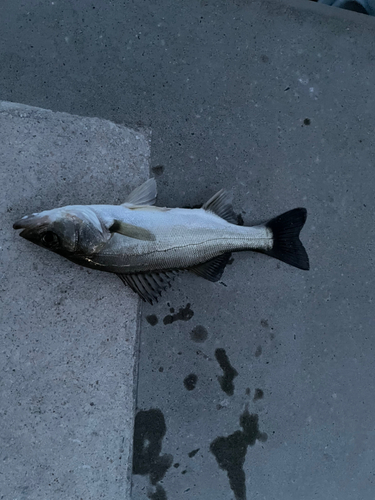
133, 408, 173, 500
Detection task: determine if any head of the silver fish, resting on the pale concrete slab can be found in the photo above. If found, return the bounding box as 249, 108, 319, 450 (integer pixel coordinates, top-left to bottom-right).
13, 206, 110, 258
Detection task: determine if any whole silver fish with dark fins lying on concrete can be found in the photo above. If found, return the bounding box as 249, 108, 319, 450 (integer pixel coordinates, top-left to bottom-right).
13, 178, 309, 304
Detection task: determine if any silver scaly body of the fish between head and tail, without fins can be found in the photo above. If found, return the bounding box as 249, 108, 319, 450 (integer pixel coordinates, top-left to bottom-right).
79, 206, 272, 273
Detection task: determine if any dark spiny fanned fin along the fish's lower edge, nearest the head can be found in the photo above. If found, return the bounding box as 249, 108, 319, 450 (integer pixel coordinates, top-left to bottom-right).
117, 271, 178, 304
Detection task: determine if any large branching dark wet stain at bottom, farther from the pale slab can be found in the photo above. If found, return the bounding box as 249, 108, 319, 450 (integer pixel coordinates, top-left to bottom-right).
210, 408, 267, 500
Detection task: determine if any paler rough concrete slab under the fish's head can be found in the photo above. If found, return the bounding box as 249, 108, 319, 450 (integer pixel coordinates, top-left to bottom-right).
0, 102, 149, 500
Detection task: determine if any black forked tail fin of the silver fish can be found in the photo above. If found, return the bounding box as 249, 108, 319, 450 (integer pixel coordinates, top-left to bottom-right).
264, 208, 310, 270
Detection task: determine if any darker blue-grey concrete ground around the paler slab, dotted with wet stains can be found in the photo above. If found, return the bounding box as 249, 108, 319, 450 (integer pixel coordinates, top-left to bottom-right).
0, 0, 375, 500
